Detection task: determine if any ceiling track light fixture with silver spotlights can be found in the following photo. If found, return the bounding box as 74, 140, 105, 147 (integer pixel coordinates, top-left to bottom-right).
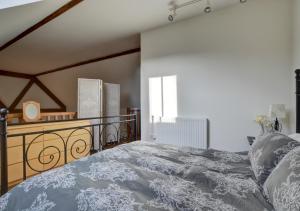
168, 0, 247, 22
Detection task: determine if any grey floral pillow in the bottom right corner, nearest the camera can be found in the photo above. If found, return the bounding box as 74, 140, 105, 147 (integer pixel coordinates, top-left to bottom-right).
264, 147, 300, 211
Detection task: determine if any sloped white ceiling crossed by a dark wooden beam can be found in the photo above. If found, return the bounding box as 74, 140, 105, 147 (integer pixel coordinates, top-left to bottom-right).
0, 0, 239, 74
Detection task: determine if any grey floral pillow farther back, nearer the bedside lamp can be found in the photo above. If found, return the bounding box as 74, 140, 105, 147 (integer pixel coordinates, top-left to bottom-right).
249, 133, 300, 185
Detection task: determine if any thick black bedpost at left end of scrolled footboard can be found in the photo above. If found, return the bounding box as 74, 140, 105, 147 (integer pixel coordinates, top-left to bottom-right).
0, 108, 8, 195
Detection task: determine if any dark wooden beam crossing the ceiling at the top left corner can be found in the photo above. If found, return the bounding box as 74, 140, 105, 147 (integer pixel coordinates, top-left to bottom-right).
0, 0, 83, 51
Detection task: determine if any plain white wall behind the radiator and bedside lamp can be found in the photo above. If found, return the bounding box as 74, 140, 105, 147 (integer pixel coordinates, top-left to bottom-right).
141, 0, 292, 151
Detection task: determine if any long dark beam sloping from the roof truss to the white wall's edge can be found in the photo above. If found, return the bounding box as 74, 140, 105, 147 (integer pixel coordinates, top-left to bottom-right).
35, 48, 141, 76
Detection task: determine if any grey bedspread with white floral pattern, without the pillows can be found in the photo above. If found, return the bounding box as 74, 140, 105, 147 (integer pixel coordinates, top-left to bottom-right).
0, 142, 273, 211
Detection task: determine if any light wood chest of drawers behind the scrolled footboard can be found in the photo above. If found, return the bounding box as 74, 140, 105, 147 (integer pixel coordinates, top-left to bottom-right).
7, 121, 92, 187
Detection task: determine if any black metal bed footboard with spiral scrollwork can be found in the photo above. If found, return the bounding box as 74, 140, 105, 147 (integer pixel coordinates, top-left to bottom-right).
0, 108, 137, 195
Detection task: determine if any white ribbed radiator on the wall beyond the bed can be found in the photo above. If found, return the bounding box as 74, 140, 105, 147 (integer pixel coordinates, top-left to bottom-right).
152, 117, 208, 149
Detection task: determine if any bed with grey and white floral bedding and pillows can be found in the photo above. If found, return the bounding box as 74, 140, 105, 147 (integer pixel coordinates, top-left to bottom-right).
0, 70, 300, 211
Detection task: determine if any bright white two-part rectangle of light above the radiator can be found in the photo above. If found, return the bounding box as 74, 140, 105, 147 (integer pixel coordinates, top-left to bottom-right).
149, 75, 177, 121
